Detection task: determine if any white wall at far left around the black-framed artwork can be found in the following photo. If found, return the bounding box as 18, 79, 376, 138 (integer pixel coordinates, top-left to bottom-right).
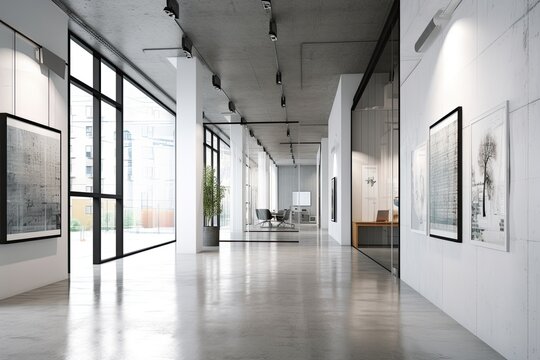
0, 0, 69, 299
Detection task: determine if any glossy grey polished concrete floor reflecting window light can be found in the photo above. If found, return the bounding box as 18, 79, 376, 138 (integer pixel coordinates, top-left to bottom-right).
0, 231, 500, 360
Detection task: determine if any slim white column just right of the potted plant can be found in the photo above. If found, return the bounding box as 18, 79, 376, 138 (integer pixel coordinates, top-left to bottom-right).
231, 125, 246, 233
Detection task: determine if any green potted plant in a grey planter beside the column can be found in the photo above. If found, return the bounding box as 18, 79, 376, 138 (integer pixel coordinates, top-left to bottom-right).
203, 166, 226, 246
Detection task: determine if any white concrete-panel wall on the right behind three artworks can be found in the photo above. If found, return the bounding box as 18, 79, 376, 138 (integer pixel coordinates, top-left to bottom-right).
400, 0, 540, 359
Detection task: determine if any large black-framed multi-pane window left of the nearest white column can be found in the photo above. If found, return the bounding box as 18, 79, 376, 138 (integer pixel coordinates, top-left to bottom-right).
69, 37, 175, 269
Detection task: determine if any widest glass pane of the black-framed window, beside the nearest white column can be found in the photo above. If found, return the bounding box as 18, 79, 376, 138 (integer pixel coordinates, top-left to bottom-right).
124, 79, 175, 253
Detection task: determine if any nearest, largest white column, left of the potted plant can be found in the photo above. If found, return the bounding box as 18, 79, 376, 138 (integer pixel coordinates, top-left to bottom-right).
176, 58, 204, 254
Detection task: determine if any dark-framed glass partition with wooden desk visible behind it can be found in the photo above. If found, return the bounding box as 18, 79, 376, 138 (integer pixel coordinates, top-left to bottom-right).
351, 23, 399, 275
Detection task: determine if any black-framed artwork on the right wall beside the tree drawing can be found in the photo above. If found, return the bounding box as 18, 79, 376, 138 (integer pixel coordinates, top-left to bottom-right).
428, 107, 462, 242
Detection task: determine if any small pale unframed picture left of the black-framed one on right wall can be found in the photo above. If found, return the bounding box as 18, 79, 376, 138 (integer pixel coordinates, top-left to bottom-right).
411, 143, 428, 235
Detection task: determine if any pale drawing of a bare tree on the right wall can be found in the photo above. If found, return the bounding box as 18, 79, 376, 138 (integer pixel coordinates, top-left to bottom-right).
471, 102, 509, 251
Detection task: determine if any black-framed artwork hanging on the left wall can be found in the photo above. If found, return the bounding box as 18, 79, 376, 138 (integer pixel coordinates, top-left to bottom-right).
0, 113, 62, 244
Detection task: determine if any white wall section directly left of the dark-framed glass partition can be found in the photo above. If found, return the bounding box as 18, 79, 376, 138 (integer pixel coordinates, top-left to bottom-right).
327, 74, 362, 245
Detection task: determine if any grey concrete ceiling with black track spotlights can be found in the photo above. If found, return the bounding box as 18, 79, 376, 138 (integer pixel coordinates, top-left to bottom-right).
54, 0, 392, 164
